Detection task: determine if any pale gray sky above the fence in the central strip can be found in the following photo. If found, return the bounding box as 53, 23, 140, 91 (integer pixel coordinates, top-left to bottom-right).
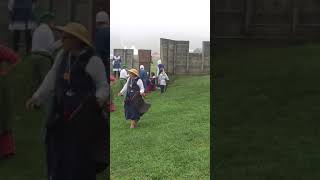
110, 0, 210, 52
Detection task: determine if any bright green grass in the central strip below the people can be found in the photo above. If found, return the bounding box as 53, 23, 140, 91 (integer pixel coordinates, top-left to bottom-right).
111, 76, 210, 180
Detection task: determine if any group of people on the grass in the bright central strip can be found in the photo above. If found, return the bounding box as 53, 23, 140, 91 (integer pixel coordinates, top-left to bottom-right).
114, 60, 169, 128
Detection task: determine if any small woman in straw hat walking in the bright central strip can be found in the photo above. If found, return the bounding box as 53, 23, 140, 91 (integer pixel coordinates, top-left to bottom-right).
118, 69, 149, 128
